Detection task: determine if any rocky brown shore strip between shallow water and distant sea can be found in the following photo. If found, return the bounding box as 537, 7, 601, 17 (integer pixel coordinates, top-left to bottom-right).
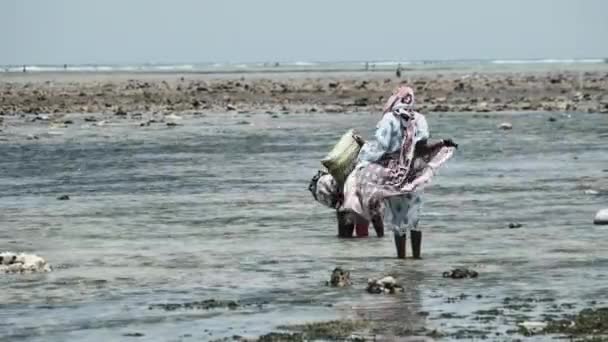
0, 71, 608, 123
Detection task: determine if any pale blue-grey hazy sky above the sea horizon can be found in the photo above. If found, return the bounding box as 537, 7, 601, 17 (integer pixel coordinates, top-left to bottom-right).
0, 0, 608, 64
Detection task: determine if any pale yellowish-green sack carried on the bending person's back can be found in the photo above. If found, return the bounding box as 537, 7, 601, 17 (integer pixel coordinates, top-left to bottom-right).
321, 129, 361, 185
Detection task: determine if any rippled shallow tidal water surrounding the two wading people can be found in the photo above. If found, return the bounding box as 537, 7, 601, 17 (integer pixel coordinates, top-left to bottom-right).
0, 114, 608, 341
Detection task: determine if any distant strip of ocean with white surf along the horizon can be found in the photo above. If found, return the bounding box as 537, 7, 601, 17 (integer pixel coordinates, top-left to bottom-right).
0, 58, 608, 73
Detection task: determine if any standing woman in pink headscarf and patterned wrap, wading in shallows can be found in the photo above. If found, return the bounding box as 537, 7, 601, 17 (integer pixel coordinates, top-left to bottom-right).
342, 86, 458, 259
